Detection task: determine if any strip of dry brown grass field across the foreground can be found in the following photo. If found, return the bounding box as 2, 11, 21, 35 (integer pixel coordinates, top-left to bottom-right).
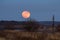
0, 30, 60, 40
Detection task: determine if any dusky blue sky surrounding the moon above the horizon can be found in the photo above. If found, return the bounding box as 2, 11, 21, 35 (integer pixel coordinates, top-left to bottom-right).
0, 0, 60, 21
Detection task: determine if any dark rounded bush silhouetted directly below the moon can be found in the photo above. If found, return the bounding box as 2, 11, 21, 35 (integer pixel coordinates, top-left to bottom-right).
24, 20, 40, 31
